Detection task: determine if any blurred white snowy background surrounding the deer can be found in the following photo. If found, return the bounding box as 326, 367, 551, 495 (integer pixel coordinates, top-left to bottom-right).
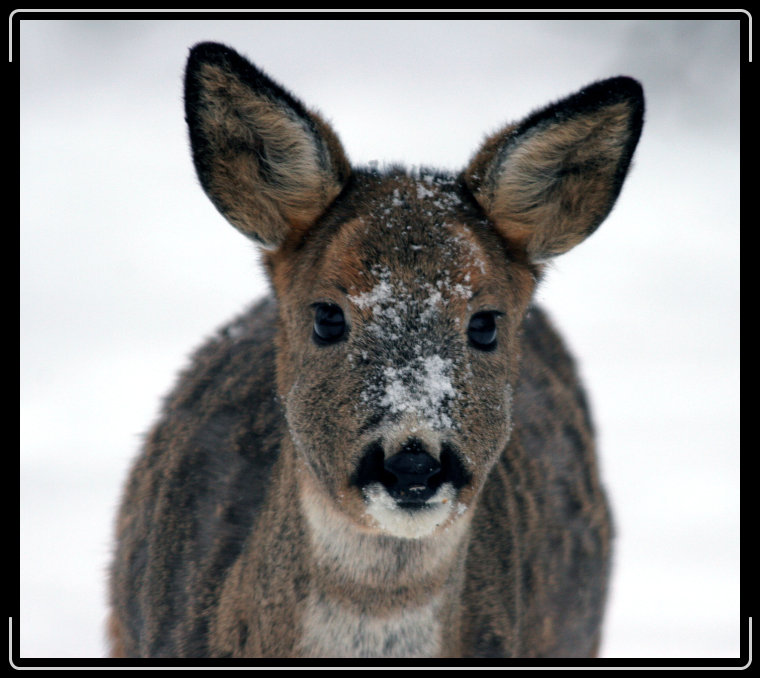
19, 14, 747, 658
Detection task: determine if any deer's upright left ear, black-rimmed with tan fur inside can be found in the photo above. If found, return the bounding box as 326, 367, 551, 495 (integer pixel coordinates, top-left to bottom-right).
185, 43, 350, 249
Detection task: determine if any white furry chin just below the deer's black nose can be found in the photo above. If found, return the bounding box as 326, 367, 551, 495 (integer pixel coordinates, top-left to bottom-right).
364, 483, 467, 539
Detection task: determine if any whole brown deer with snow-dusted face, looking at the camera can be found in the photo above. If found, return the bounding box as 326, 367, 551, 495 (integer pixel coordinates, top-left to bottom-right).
107, 42, 644, 658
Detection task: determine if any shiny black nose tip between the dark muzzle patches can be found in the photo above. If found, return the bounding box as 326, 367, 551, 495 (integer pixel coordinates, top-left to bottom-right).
381, 438, 442, 504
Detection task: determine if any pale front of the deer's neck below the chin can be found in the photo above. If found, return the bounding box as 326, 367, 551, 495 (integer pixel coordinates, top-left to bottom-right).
297, 452, 470, 657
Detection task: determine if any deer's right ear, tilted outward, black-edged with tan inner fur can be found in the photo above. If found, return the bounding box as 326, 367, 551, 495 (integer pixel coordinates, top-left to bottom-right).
464, 77, 644, 261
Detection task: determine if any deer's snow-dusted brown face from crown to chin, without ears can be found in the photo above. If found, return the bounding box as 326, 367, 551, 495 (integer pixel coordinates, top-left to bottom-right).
273, 172, 533, 538
